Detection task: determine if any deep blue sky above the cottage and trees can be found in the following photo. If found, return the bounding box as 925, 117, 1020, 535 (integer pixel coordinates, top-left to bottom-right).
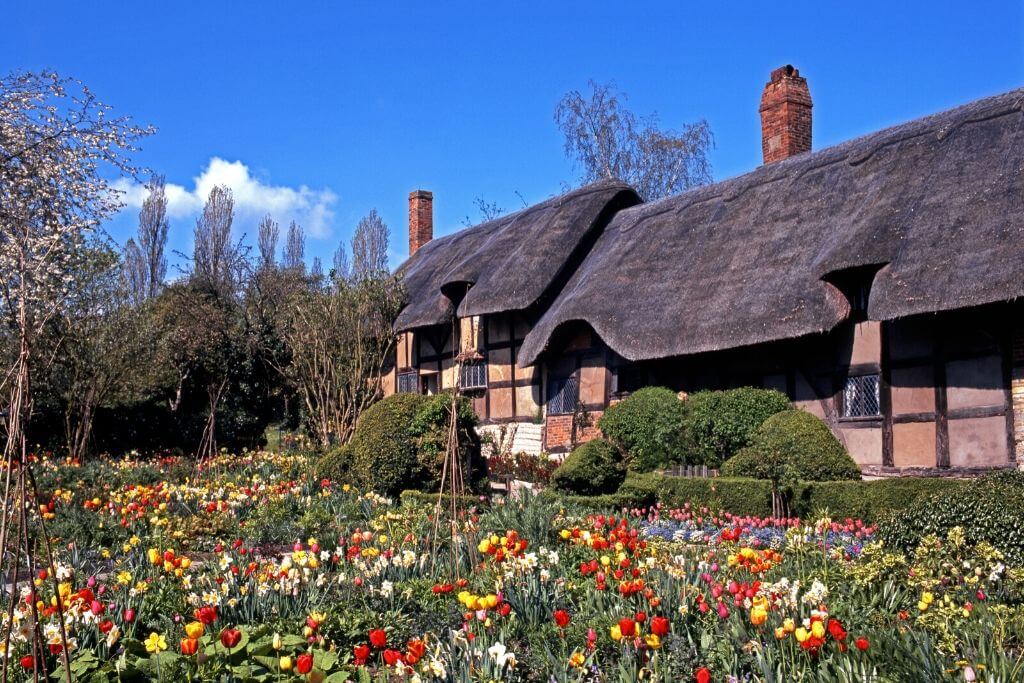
0, 0, 1024, 270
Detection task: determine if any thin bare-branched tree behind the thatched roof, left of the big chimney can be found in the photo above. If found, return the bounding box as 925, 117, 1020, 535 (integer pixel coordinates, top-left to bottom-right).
555, 81, 714, 200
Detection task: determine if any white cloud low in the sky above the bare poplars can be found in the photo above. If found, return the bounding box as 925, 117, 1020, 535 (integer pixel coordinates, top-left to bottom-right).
115, 157, 338, 238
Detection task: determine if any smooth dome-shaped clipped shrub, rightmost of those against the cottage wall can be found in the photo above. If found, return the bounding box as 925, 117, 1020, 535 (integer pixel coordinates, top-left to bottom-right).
722, 410, 860, 481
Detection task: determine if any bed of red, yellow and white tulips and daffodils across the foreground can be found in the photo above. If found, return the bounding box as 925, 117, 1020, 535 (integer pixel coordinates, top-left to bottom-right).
4, 454, 1024, 681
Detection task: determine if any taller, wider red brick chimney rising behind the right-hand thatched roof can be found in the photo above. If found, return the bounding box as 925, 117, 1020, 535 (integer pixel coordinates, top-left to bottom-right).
759, 65, 812, 164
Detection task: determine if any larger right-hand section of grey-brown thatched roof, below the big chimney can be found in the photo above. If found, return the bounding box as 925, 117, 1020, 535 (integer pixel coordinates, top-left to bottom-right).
519, 90, 1024, 365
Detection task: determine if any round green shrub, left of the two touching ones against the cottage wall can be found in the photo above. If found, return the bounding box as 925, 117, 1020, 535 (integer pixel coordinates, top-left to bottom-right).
598, 387, 687, 472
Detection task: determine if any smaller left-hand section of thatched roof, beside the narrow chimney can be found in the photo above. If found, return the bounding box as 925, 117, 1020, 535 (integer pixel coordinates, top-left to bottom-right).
395, 180, 640, 332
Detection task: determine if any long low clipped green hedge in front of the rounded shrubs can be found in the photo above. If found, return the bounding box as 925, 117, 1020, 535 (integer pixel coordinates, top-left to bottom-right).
562, 472, 970, 522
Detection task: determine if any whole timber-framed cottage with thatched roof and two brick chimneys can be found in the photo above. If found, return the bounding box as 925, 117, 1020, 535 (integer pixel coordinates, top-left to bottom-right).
386, 67, 1024, 473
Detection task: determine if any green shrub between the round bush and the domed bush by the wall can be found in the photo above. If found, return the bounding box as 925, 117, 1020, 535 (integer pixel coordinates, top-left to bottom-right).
684, 387, 792, 467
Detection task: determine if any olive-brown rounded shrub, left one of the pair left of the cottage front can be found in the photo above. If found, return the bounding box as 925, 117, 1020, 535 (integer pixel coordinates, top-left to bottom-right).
349, 393, 427, 497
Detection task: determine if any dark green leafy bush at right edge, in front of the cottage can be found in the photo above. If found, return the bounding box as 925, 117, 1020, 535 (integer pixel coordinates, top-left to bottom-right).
879, 472, 1024, 564
